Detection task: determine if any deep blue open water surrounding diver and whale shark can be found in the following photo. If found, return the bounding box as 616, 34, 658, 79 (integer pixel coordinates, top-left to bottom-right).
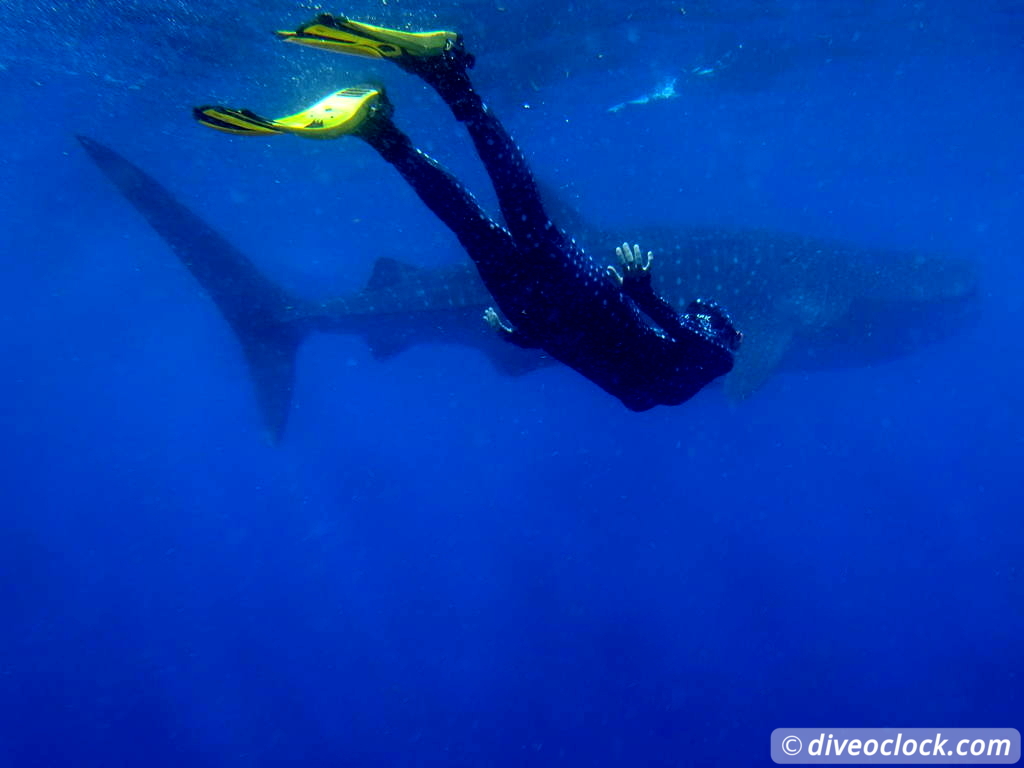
0, 0, 1024, 767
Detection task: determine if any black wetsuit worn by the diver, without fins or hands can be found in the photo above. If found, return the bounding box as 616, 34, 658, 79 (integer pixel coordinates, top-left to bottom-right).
361, 49, 739, 411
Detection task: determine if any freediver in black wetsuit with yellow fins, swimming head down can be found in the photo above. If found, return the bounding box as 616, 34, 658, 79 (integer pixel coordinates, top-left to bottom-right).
195, 14, 740, 411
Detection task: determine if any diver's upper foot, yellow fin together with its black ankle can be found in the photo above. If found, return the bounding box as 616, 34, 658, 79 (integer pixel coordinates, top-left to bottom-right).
278, 13, 473, 76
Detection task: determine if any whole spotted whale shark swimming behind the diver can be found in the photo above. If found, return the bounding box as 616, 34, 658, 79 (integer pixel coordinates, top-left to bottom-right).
77, 136, 979, 441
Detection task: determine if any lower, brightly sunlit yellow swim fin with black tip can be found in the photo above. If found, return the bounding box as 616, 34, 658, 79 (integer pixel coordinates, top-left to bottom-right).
193, 87, 393, 138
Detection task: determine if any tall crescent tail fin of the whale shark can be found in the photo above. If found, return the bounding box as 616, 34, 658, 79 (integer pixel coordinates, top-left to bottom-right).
77, 136, 313, 442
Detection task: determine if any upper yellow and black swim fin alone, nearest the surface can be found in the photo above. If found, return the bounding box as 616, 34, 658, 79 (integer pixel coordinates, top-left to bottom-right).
276, 13, 459, 58
